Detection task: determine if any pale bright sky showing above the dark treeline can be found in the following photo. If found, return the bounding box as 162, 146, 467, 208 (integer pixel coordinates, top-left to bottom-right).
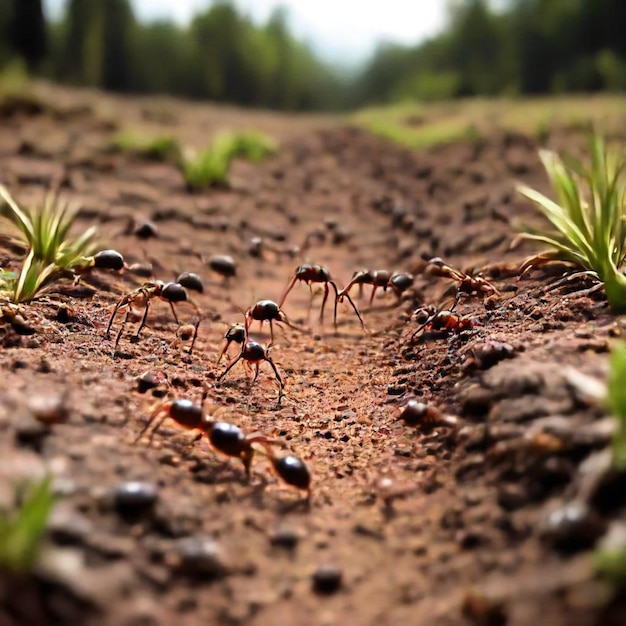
44, 0, 446, 64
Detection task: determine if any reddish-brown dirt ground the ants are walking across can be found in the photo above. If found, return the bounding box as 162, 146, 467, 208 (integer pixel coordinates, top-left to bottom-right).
0, 84, 626, 626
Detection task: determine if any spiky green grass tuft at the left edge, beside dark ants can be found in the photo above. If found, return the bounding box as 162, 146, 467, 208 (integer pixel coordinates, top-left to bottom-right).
0, 185, 96, 302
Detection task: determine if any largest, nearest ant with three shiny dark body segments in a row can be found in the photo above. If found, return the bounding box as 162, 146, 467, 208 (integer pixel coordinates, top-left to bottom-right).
135, 392, 311, 501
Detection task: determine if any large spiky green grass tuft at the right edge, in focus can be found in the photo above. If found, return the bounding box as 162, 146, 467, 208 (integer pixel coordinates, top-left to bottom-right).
517, 134, 626, 313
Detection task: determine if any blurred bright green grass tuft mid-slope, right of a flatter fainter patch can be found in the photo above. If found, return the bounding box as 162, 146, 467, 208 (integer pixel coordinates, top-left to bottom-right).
181, 131, 276, 191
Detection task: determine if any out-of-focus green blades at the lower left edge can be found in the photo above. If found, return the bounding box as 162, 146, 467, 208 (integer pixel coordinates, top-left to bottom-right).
0, 476, 54, 573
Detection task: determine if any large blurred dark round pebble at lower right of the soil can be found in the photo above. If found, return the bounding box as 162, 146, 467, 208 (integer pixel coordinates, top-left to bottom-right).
540, 502, 606, 553
